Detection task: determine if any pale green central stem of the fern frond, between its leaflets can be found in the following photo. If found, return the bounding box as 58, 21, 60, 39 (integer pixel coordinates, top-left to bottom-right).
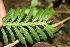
3, 21, 47, 27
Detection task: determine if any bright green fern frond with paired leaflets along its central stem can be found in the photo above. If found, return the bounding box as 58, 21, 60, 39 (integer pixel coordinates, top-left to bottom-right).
1, 6, 57, 44
